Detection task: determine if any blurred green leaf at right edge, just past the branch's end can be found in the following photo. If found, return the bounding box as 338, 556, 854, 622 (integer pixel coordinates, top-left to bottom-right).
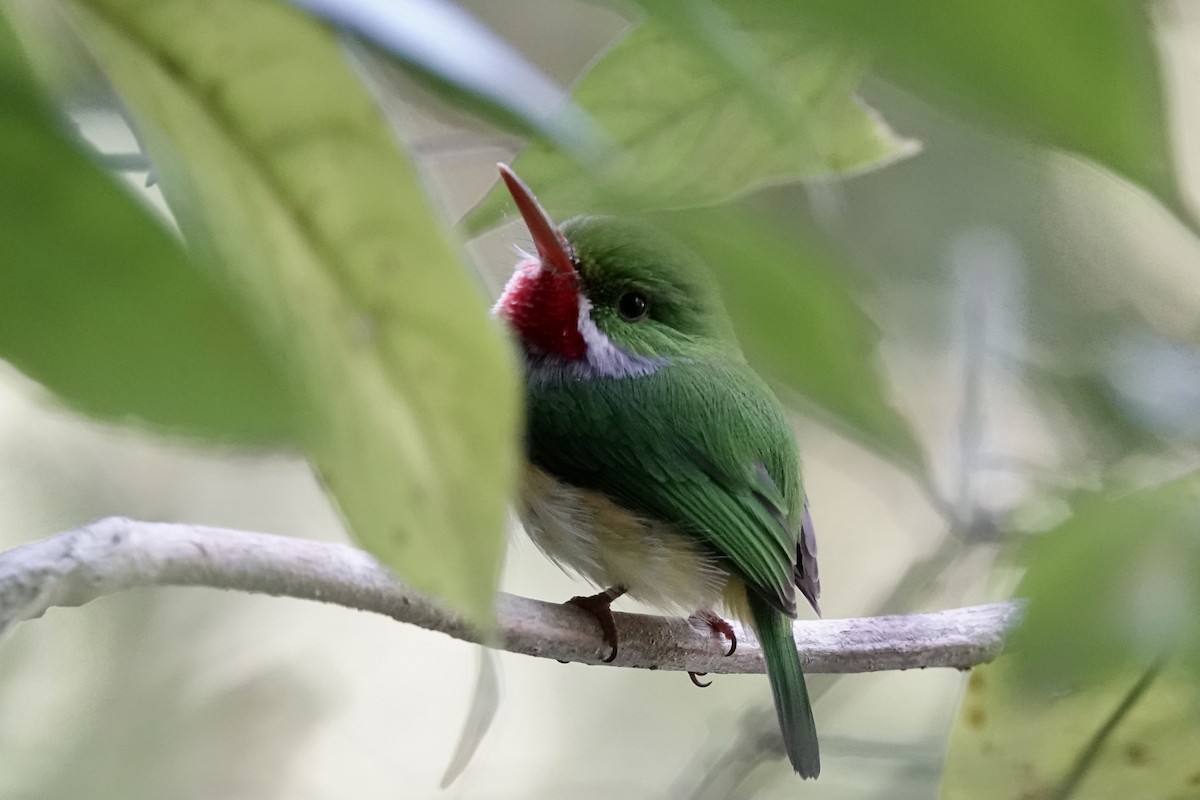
1013, 473, 1200, 680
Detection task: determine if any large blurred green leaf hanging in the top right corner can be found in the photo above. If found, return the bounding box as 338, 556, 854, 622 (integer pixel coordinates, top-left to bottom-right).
768, 0, 1180, 221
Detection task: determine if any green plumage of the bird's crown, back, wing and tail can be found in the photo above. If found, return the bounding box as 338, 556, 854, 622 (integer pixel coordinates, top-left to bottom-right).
526, 217, 820, 777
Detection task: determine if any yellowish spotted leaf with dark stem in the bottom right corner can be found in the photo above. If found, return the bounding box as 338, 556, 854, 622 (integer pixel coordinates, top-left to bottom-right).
941, 657, 1200, 800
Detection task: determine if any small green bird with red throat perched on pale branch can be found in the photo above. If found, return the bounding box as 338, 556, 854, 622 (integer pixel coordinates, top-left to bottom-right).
496, 164, 821, 777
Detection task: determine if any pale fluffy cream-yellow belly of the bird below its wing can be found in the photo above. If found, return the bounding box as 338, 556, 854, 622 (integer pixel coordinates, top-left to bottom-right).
520, 465, 740, 614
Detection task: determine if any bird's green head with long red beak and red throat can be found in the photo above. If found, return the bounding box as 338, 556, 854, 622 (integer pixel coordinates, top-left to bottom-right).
496, 164, 740, 377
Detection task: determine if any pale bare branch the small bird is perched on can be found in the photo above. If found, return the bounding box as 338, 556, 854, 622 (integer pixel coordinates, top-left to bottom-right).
0, 517, 1021, 673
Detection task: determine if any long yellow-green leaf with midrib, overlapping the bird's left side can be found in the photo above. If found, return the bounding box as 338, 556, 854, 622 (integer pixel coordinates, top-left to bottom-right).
69, 0, 518, 624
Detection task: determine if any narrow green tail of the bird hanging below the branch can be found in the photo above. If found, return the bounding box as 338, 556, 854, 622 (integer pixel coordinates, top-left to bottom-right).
749, 595, 821, 777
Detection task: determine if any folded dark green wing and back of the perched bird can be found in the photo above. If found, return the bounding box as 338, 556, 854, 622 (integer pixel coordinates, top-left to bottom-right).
527, 362, 803, 616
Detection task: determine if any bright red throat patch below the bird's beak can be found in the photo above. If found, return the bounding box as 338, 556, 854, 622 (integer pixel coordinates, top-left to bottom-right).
497, 260, 588, 361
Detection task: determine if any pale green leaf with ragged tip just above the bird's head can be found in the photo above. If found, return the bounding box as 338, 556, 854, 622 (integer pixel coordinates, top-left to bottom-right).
466, 18, 916, 231
